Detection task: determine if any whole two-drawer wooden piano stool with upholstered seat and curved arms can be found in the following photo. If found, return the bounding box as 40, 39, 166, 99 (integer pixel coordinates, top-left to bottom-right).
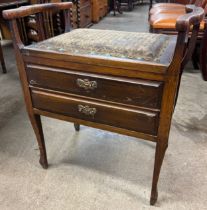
4, 3, 204, 205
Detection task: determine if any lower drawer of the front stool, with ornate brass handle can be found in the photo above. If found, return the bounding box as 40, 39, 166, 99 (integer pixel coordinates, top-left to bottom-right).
31, 90, 158, 135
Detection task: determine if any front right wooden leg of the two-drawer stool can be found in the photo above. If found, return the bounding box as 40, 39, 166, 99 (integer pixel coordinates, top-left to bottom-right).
150, 142, 167, 205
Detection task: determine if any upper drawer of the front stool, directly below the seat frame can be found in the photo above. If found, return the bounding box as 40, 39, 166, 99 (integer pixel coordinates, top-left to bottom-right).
27, 64, 163, 109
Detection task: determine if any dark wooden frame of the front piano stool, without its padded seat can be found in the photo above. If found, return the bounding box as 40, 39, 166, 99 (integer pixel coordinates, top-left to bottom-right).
4, 3, 204, 205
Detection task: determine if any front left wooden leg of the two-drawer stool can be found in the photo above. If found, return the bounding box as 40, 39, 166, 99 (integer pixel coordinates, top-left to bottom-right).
30, 115, 48, 169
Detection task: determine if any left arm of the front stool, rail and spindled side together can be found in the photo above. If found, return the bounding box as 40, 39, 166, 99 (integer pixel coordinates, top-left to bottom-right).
3, 2, 72, 45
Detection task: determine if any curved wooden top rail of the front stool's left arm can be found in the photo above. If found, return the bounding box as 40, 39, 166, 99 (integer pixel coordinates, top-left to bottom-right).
3, 2, 73, 20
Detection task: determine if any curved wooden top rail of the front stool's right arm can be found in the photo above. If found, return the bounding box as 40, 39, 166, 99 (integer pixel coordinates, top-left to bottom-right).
176, 5, 204, 32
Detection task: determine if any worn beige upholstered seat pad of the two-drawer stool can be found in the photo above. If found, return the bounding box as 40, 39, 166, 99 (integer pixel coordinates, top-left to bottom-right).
29, 29, 175, 63
